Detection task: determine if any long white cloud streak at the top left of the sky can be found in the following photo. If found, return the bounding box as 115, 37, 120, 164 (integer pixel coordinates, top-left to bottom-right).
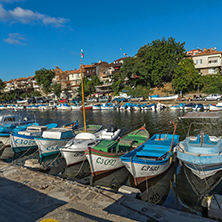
0, 4, 69, 27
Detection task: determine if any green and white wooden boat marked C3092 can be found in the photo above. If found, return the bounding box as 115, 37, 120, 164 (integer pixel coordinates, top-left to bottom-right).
85, 126, 150, 177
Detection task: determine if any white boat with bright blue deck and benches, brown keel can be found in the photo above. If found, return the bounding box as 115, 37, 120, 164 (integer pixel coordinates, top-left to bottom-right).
120, 122, 179, 185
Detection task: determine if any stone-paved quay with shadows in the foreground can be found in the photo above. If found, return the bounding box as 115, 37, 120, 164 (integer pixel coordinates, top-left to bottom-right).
0, 162, 214, 222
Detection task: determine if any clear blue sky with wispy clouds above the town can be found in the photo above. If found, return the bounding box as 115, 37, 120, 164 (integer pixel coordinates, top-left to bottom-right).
0, 0, 222, 81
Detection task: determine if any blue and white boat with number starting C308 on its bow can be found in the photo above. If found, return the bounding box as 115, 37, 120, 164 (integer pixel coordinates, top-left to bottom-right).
10, 123, 58, 153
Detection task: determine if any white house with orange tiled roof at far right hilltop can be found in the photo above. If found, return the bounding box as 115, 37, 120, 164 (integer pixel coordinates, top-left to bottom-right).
191, 48, 222, 75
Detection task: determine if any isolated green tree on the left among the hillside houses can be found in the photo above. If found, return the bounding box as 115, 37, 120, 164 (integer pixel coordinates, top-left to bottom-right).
35, 68, 55, 94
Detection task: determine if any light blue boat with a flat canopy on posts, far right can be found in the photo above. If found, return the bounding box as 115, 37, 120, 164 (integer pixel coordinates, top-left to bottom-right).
176, 112, 222, 179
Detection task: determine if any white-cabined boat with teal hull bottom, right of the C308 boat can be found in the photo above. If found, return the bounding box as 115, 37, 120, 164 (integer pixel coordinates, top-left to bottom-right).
35, 128, 74, 159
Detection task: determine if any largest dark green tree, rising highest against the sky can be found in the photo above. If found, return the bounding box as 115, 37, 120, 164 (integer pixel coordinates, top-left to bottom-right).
121, 37, 186, 87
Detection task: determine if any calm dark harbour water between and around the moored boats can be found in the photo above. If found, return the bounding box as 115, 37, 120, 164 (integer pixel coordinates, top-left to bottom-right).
0, 110, 222, 218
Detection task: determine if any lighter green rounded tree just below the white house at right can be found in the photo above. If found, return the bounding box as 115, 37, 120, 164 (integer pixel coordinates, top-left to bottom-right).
172, 58, 201, 92
